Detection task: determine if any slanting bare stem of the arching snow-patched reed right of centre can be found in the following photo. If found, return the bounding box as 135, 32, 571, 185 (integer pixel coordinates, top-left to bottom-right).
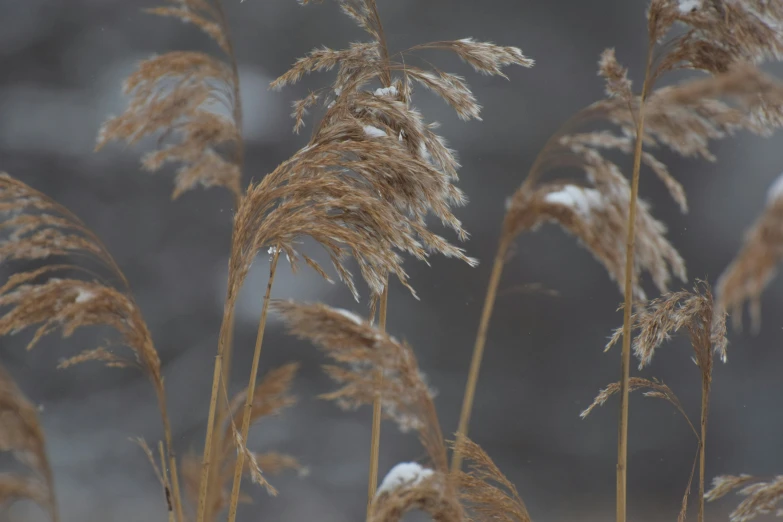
451, 237, 511, 473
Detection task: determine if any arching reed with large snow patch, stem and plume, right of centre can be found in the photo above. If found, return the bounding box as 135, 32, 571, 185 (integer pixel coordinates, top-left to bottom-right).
459, 58, 783, 476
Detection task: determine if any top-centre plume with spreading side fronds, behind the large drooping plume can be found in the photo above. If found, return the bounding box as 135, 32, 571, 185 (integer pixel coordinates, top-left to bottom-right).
272, 0, 533, 276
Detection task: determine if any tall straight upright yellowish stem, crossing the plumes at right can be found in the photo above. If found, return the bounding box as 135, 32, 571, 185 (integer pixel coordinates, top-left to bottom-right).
616, 42, 654, 522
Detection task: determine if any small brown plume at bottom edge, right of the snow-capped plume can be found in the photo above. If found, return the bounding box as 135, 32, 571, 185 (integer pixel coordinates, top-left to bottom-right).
454, 438, 531, 522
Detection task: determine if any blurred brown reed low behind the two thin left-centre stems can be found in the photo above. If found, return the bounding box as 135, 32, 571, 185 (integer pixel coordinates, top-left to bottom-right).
182, 363, 307, 520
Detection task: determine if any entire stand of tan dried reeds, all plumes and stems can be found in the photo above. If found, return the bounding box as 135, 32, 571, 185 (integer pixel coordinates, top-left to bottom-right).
7, 0, 783, 522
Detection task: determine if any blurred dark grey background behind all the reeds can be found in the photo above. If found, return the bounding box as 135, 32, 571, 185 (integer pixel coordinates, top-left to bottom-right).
0, 0, 783, 522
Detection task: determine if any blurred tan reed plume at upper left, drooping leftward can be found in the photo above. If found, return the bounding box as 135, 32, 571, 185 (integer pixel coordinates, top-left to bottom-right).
96, 0, 244, 202
